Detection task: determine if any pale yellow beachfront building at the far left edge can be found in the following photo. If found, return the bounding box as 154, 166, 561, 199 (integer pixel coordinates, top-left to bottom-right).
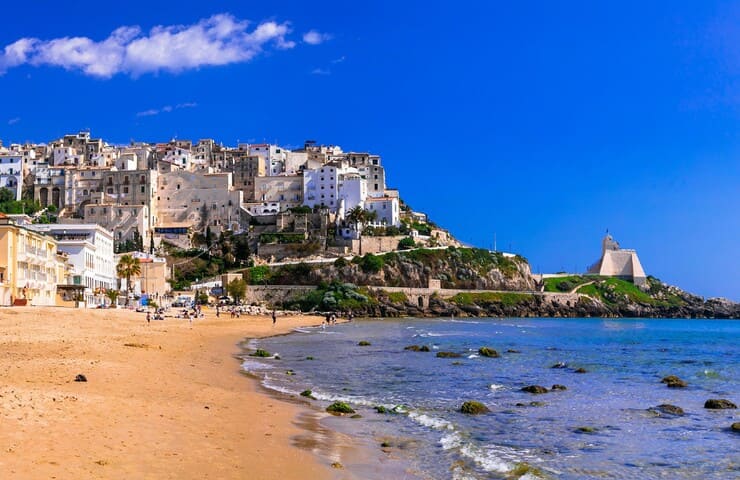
0, 213, 64, 306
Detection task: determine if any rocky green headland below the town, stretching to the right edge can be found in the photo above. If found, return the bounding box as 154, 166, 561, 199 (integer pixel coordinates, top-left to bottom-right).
251, 248, 740, 318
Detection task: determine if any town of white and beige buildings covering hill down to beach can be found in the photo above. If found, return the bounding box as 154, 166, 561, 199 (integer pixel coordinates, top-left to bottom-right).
0, 131, 457, 305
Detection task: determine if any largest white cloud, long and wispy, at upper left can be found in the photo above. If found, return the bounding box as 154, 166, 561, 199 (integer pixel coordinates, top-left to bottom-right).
0, 14, 296, 78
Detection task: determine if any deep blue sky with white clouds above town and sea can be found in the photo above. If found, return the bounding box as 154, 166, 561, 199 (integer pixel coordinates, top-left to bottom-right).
0, 0, 740, 300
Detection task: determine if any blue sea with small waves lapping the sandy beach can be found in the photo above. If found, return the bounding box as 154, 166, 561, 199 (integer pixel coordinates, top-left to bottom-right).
243, 318, 740, 480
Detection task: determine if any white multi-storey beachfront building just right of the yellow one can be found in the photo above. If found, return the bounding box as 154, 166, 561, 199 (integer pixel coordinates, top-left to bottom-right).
29, 223, 116, 306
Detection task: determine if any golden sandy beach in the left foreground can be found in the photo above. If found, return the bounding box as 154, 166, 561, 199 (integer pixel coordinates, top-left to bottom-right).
0, 307, 348, 479
